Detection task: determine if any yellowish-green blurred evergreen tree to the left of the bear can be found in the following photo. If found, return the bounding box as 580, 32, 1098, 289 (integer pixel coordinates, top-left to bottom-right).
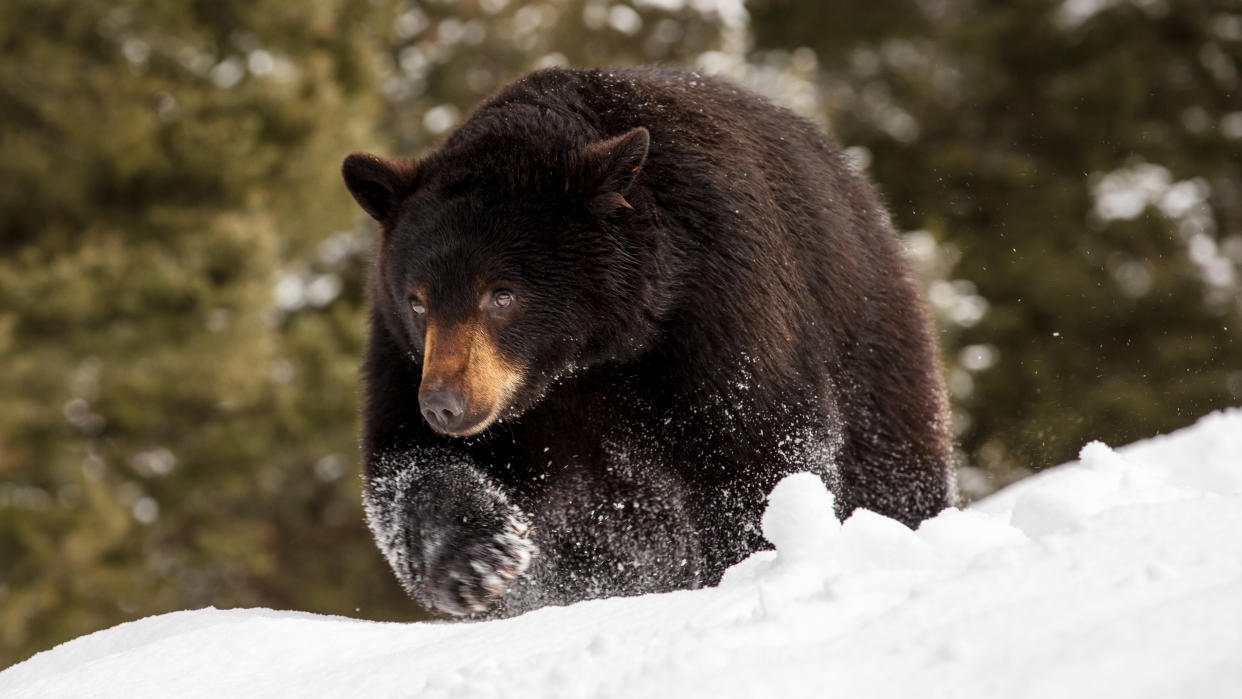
0, 0, 412, 664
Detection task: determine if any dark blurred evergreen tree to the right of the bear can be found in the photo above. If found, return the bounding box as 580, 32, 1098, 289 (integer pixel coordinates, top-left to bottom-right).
751, 0, 1242, 482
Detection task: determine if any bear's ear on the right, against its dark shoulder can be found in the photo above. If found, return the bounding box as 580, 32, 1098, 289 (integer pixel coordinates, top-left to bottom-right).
566, 127, 651, 217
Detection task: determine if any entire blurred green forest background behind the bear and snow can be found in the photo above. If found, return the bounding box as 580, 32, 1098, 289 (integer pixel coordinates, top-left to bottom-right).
0, 0, 1242, 667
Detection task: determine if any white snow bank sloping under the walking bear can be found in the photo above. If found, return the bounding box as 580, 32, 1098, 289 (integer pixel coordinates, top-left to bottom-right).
0, 410, 1242, 698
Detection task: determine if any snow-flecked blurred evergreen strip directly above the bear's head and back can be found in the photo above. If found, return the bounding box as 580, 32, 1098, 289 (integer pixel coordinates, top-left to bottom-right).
379, 0, 749, 154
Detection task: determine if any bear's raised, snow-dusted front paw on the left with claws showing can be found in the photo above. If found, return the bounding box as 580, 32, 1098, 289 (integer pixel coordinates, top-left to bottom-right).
365, 454, 539, 615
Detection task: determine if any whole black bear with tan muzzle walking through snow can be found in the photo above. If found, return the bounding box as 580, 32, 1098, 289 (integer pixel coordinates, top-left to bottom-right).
343, 68, 954, 615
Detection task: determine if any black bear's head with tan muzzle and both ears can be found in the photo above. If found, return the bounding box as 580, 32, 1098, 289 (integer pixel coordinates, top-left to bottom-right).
343, 120, 668, 437
